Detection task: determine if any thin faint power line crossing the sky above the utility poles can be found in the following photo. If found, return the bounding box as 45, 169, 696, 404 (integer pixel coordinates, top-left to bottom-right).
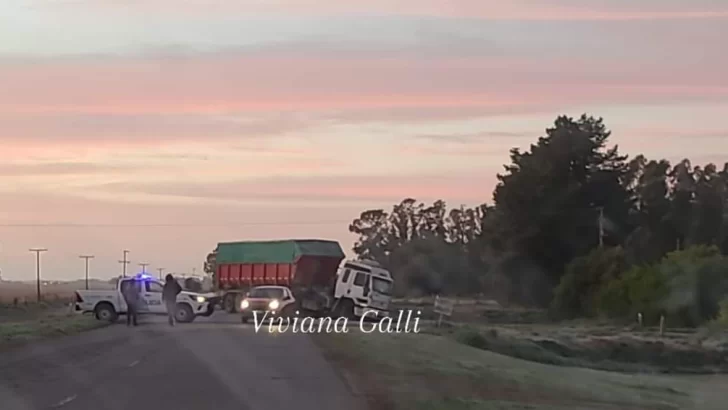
0, 220, 351, 228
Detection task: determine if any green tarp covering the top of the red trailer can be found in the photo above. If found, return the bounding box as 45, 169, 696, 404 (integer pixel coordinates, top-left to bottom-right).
217, 239, 345, 264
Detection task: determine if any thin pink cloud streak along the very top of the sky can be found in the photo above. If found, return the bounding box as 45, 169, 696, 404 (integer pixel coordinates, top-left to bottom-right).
57, 0, 728, 21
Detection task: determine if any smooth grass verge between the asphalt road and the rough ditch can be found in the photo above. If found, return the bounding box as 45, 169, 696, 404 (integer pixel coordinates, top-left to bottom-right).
315, 333, 728, 410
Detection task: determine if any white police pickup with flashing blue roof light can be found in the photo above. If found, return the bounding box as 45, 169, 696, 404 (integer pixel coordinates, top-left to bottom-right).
75, 275, 214, 323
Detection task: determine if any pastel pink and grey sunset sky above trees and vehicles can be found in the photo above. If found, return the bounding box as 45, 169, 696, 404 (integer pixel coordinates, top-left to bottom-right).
0, 0, 728, 280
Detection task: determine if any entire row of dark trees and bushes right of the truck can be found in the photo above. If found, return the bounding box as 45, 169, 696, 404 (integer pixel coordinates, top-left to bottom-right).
349, 114, 728, 326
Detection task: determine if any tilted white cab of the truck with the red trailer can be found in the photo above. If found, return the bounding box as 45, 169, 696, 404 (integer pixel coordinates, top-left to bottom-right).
334, 261, 394, 317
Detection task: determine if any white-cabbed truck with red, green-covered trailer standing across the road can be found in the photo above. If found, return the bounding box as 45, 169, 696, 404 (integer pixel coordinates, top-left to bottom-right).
208, 239, 393, 322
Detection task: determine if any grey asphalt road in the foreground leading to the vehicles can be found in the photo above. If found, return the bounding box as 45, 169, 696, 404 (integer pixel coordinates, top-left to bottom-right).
0, 313, 363, 410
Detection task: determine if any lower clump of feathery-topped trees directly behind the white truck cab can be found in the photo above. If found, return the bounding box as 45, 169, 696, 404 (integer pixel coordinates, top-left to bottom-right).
349, 198, 488, 294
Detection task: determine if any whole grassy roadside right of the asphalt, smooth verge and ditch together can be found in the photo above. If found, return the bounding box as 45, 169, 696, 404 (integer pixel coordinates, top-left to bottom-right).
315, 299, 728, 410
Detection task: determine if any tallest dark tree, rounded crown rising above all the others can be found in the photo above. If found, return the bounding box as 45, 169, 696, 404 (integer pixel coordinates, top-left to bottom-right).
493, 115, 631, 284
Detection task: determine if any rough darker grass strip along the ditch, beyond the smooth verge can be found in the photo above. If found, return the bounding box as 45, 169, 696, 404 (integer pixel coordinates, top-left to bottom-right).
390, 301, 728, 374
